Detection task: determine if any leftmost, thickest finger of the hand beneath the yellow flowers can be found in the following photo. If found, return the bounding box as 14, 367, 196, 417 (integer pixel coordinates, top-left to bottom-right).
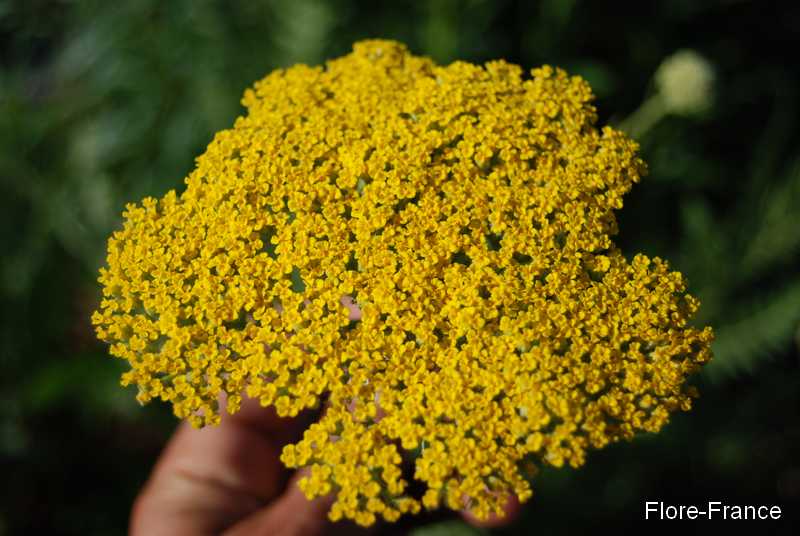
131, 400, 296, 535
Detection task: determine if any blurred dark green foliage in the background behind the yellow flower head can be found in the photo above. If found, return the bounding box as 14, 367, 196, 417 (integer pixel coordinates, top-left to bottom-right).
0, 0, 800, 535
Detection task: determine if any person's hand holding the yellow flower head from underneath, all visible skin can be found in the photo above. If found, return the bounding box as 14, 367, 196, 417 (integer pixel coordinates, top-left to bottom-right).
130, 299, 519, 536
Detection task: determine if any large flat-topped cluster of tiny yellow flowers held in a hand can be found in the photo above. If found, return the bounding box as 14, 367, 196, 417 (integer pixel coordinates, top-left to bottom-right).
93, 40, 712, 525
